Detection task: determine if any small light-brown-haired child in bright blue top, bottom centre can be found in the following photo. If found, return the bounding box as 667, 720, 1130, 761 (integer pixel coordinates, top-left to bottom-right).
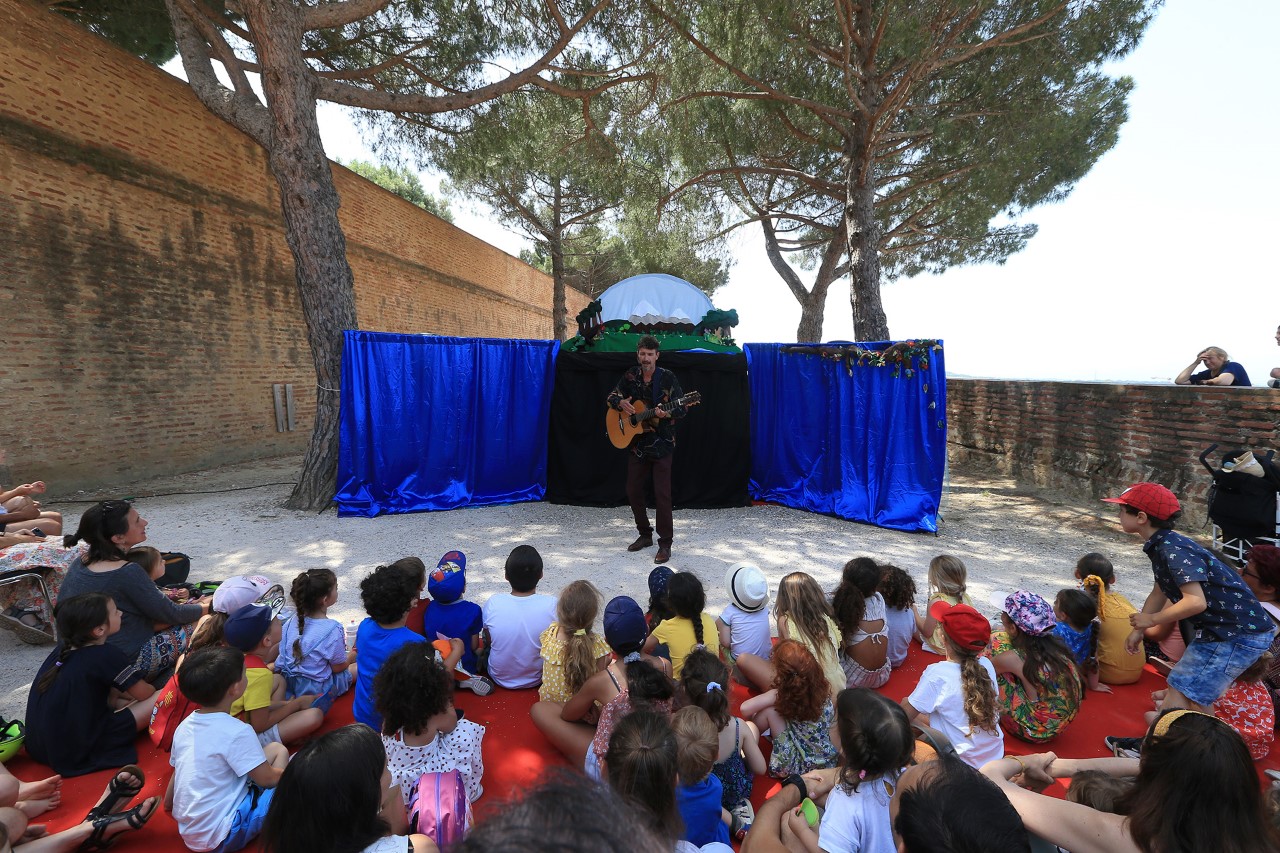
671, 706, 731, 847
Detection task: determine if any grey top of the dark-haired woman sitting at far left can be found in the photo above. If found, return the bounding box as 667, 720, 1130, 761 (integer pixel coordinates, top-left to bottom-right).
58, 557, 204, 660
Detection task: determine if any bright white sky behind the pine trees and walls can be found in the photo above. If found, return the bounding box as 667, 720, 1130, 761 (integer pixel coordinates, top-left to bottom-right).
169, 0, 1280, 384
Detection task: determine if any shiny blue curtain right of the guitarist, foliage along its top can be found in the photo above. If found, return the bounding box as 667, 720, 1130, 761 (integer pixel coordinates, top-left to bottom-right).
745, 343, 947, 532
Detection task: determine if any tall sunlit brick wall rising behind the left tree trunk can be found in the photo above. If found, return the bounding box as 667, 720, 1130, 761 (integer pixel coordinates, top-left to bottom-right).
0, 0, 589, 492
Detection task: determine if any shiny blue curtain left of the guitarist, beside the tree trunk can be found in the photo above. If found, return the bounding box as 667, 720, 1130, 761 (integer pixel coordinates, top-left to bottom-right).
334, 332, 559, 516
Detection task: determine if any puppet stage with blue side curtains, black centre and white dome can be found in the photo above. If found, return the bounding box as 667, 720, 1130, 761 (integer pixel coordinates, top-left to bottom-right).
334, 277, 946, 533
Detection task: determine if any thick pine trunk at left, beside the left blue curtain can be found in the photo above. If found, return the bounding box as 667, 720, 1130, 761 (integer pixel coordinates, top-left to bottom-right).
239, 0, 356, 510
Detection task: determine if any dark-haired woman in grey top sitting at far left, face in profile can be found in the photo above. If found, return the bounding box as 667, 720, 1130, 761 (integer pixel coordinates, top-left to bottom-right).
58, 501, 211, 681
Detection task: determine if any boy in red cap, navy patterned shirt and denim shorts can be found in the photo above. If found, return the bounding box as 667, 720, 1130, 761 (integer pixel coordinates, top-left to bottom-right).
1103, 483, 1275, 713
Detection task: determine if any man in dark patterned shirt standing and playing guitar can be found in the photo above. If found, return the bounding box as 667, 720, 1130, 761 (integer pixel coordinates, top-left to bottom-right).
607, 334, 685, 564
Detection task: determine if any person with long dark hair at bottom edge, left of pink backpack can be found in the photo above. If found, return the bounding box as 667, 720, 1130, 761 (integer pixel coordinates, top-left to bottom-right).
260, 722, 438, 853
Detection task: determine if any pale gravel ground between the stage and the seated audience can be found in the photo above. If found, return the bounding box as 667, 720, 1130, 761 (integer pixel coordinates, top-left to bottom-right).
0, 457, 1177, 719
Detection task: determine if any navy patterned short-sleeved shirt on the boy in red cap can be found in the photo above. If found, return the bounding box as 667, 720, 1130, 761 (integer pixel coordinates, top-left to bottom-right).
1142, 530, 1275, 642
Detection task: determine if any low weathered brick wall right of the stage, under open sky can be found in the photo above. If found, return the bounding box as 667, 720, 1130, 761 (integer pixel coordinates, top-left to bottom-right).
947, 379, 1280, 500
